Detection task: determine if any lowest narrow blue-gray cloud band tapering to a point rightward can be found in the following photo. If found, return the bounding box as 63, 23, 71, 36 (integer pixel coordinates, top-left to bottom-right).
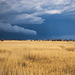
0, 22, 37, 35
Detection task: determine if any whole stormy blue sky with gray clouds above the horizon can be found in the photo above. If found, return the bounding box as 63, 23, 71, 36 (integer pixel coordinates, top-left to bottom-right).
0, 0, 75, 39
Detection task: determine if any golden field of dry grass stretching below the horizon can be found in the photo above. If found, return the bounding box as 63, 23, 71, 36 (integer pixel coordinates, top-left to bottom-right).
0, 40, 75, 75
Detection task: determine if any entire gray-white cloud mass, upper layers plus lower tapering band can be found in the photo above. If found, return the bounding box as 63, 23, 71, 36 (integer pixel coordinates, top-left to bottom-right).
0, 0, 75, 35
